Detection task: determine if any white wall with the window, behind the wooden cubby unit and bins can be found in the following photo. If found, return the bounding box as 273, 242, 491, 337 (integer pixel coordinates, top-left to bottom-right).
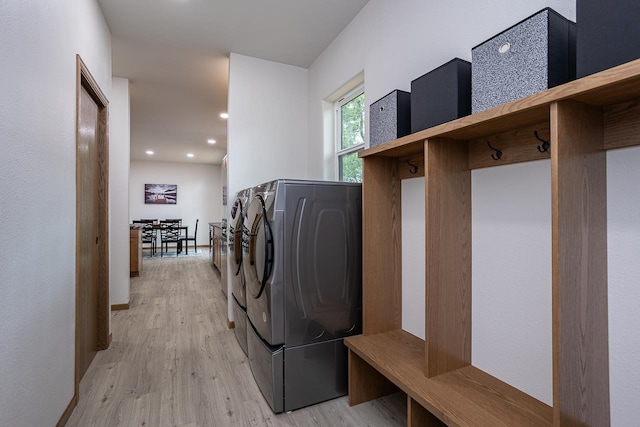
308, 0, 640, 426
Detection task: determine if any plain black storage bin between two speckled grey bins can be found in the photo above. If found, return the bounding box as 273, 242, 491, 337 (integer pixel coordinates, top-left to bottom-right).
411, 58, 471, 133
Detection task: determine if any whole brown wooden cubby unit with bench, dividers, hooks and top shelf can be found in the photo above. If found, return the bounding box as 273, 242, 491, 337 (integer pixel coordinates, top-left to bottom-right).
345, 60, 640, 427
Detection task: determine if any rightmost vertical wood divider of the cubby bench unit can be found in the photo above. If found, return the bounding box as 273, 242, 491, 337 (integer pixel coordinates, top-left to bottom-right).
551, 101, 610, 427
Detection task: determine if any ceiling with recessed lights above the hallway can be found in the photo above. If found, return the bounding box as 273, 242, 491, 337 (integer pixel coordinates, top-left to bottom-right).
98, 0, 368, 163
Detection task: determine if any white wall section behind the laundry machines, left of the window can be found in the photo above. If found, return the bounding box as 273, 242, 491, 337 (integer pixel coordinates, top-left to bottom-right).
227, 53, 310, 320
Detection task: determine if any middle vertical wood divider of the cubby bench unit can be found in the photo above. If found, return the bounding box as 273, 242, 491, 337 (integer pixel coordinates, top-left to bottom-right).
425, 138, 471, 377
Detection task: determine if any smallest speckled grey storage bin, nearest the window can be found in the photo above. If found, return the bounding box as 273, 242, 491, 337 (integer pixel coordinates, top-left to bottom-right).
369, 90, 411, 147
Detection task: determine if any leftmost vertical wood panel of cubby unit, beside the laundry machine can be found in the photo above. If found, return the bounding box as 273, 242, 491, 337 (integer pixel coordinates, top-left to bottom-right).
362, 156, 402, 335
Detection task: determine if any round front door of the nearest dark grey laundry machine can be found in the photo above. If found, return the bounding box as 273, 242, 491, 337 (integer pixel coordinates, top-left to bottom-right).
242, 195, 274, 299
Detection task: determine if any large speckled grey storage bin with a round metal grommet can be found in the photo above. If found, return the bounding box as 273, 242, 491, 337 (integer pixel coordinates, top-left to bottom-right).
471, 8, 576, 113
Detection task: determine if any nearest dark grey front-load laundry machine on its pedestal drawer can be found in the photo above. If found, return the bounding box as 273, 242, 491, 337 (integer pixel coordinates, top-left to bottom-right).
242, 180, 362, 413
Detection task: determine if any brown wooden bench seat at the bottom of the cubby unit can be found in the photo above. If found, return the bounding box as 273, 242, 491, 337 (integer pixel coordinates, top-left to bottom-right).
345, 330, 553, 426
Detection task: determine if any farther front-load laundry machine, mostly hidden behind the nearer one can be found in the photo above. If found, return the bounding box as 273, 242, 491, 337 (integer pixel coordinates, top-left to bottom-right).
228, 188, 251, 355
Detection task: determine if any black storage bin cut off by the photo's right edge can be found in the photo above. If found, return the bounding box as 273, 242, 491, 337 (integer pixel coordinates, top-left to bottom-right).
576, 0, 640, 78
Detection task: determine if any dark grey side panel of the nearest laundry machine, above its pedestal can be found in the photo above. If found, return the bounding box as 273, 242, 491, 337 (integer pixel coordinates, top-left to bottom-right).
284, 185, 362, 346
